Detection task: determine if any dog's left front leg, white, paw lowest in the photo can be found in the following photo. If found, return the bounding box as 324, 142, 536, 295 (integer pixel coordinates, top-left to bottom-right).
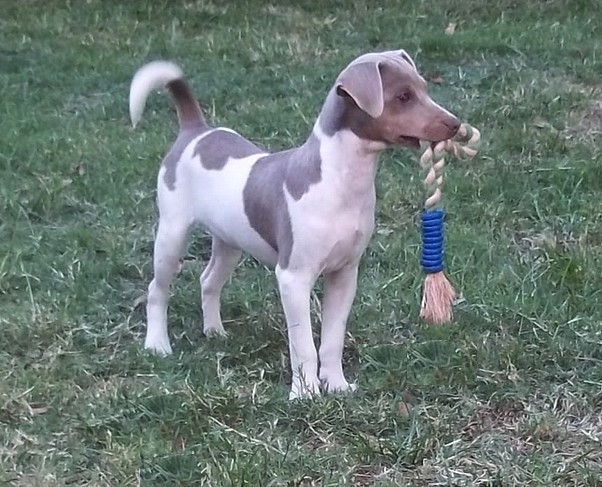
276, 266, 320, 399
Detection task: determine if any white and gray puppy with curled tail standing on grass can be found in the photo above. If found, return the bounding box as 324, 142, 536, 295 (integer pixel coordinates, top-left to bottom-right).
129, 50, 460, 399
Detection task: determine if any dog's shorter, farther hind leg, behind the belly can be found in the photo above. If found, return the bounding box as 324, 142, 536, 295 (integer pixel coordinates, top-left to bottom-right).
201, 237, 241, 335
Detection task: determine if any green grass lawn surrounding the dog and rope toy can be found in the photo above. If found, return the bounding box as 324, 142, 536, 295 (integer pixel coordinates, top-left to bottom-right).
0, 0, 602, 487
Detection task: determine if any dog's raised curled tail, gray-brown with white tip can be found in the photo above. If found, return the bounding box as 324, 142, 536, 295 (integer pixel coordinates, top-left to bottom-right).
130, 61, 207, 130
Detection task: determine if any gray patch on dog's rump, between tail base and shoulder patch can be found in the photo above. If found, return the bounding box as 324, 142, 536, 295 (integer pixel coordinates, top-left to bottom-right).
194, 129, 265, 171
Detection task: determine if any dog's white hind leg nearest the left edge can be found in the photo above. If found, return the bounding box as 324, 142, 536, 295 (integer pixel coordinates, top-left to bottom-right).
144, 218, 190, 355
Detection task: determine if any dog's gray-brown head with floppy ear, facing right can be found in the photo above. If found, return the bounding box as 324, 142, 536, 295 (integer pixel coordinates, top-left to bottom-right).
334, 50, 460, 147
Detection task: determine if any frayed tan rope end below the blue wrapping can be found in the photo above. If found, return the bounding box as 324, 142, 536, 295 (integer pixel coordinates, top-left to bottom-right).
420, 272, 456, 324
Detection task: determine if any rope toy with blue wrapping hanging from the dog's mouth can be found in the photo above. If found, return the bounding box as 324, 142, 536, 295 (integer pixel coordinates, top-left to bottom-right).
420, 124, 481, 324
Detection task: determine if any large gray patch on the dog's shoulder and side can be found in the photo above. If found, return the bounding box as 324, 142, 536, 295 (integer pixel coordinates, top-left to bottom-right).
243, 134, 322, 269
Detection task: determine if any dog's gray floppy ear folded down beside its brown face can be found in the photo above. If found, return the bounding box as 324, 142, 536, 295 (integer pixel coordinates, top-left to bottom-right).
336, 61, 385, 118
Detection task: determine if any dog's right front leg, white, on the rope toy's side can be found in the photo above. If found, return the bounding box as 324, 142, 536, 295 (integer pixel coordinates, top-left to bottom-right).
320, 263, 357, 392
